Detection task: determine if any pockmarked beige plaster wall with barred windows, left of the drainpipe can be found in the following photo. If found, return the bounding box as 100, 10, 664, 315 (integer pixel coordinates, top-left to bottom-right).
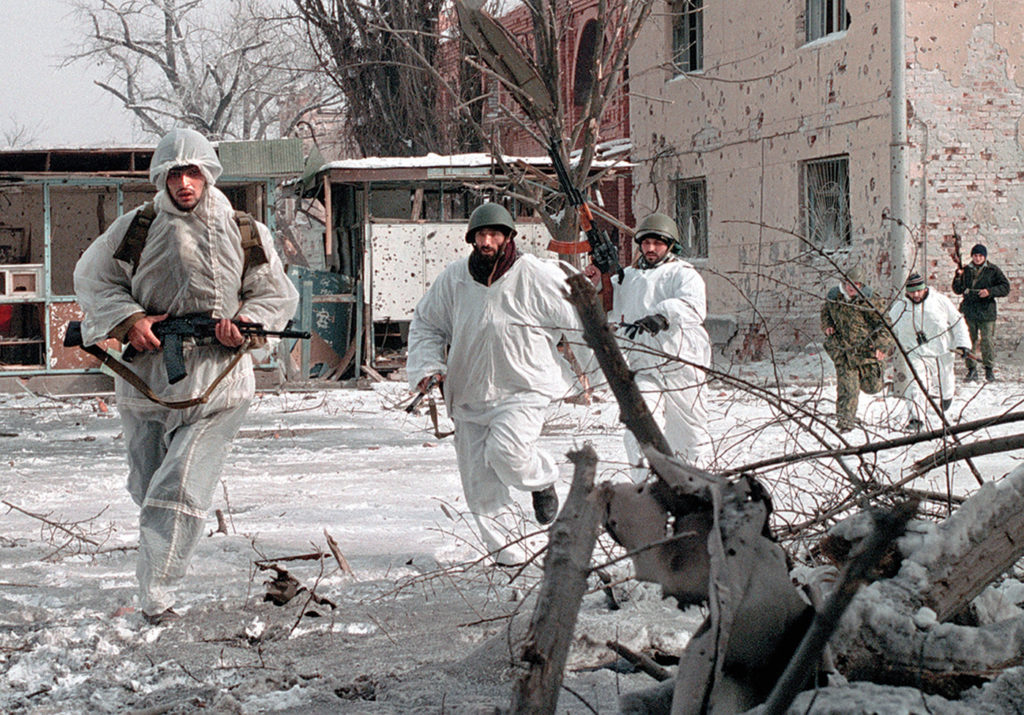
630, 0, 890, 356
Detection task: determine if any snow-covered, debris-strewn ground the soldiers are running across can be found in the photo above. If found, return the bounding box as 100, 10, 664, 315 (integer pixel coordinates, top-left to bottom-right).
0, 354, 1024, 713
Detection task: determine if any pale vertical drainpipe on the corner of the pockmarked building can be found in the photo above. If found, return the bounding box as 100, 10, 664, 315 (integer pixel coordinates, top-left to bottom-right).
889, 0, 909, 290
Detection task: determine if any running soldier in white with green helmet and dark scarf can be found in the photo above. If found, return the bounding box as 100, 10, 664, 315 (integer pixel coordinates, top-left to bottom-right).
406, 198, 580, 565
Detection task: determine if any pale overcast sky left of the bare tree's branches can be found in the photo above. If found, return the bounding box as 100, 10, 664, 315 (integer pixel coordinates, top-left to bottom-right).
0, 0, 139, 149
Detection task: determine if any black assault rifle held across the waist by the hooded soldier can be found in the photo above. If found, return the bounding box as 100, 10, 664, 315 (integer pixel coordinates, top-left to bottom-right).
63, 313, 312, 385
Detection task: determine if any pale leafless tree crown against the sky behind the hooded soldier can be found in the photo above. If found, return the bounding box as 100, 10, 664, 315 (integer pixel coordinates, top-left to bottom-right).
63, 0, 334, 139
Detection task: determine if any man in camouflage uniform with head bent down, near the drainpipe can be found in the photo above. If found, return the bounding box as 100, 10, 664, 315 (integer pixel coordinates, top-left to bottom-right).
821, 266, 893, 432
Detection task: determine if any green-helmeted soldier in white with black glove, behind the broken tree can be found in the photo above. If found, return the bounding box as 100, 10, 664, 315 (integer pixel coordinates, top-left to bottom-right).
611, 208, 711, 471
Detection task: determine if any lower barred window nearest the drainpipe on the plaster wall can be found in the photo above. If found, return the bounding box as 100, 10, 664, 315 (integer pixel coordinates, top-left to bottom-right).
801, 157, 850, 250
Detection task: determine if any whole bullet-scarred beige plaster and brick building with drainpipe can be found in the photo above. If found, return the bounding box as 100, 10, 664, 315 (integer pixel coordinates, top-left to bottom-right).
630, 0, 1024, 358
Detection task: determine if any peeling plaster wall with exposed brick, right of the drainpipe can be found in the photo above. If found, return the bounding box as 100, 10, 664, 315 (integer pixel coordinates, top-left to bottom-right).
906, 0, 1024, 356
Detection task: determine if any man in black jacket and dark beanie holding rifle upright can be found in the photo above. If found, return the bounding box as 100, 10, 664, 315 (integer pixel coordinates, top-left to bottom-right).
953, 244, 1010, 382
